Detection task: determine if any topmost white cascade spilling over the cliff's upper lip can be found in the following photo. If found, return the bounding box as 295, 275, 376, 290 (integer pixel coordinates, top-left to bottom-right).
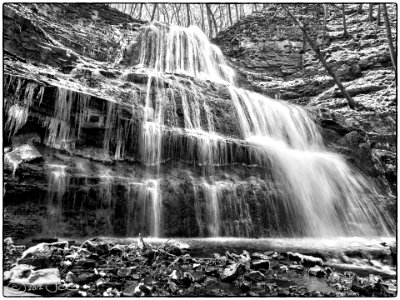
139, 22, 234, 82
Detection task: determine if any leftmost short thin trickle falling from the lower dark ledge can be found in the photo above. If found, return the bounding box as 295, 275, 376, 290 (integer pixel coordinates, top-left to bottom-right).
47, 165, 68, 235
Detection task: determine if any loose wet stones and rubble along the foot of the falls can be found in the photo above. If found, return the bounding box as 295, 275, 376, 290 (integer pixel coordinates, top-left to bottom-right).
3, 237, 397, 297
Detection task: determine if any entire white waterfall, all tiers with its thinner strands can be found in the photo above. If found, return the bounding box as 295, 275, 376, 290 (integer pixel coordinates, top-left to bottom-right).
28, 23, 392, 237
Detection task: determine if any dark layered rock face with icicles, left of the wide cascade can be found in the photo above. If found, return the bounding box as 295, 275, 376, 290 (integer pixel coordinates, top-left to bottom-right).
4, 4, 279, 239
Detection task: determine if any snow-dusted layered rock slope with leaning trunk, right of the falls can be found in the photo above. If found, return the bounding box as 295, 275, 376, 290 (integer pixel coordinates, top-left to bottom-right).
214, 4, 397, 200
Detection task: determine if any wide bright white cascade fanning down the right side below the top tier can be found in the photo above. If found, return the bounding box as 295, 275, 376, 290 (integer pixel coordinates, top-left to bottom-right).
230, 86, 389, 236
